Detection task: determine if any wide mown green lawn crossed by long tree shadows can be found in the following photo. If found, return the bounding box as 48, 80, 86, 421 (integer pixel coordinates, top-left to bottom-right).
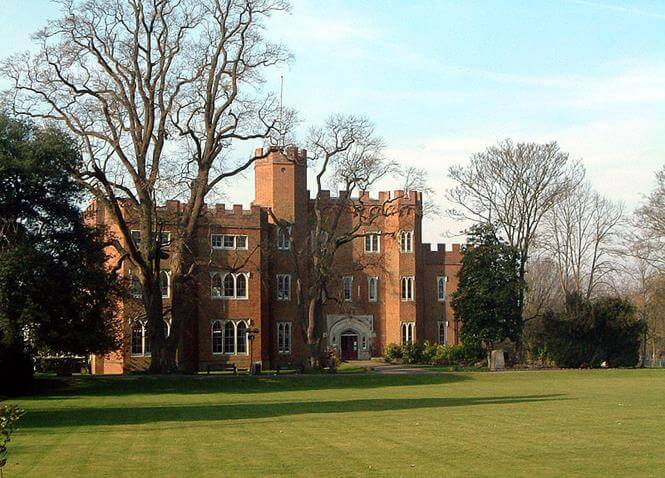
5, 370, 665, 478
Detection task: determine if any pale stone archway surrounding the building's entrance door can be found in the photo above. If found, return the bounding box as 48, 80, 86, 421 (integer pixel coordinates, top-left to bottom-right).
326, 315, 376, 360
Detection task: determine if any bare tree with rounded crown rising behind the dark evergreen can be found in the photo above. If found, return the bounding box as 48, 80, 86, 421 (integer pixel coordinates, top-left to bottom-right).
446, 139, 584, 318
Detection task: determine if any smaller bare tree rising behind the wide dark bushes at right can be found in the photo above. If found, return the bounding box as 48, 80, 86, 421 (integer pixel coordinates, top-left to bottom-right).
540, 183, 624, 299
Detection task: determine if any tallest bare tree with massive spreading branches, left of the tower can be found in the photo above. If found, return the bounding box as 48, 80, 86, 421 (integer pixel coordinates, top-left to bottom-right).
1, 0, 288, 372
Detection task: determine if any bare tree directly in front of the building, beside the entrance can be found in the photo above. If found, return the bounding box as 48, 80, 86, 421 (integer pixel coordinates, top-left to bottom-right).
273, 115, 427, 367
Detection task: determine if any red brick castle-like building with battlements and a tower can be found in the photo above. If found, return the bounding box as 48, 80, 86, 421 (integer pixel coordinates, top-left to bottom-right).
93, 148, 461, 373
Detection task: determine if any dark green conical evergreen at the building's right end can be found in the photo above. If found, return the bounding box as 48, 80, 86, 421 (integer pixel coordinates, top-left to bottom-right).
452, 224, 522, 365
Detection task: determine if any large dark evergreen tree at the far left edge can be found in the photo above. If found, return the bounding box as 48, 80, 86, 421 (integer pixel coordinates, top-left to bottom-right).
0, 115, 123, 385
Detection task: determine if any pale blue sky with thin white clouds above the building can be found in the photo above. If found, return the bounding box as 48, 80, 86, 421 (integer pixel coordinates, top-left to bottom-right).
0, 0, 665, 243
